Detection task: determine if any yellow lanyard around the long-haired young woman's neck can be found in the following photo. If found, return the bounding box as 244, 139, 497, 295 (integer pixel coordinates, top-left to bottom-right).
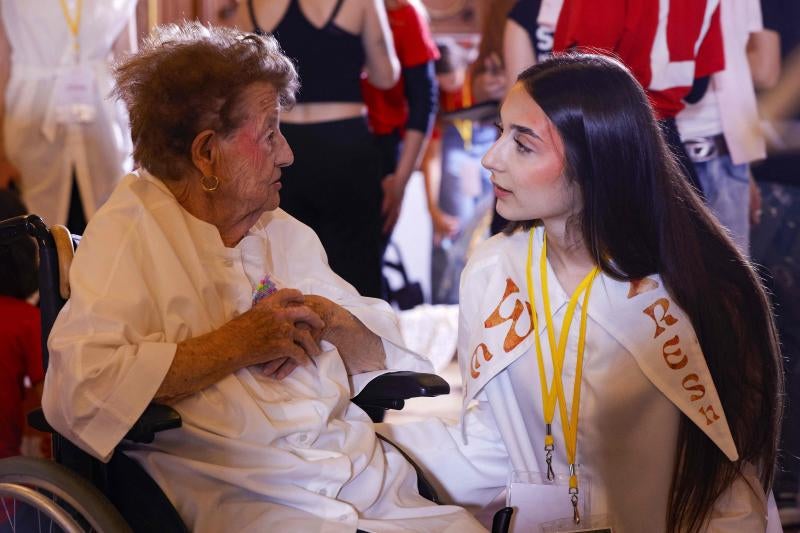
526, 228, 600, 523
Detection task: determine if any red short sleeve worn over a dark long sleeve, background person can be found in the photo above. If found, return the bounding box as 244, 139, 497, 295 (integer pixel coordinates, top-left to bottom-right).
389, 4, 439, 68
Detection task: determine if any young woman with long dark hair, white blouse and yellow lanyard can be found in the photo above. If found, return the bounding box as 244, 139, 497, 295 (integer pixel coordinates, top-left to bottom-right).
385, 54, 782, 532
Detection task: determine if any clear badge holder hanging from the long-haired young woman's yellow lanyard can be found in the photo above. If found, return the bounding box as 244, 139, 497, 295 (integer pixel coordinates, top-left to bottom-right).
506, 470, 611, 533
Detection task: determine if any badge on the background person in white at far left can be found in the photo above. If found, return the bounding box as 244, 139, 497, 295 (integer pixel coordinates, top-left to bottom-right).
53, 65, 96, 124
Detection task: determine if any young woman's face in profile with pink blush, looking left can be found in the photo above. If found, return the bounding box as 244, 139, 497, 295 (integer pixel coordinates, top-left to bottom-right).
481, 83, 581, 223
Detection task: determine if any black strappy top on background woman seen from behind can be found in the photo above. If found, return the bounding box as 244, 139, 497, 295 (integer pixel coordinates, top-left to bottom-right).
247, 0, 366, 103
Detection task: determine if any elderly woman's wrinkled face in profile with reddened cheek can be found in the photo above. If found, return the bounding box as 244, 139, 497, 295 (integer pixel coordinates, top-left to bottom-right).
218, 83, 294, 216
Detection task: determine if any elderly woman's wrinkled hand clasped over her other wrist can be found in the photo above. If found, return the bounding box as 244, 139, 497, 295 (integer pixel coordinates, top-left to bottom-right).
229, 289, 325, 379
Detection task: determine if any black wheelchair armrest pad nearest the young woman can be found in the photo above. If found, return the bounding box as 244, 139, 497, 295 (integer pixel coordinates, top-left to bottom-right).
352, 371, 450, 409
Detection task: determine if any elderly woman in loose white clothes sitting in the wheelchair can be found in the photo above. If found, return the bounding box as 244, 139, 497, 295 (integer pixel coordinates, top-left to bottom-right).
43, 23, 480, 532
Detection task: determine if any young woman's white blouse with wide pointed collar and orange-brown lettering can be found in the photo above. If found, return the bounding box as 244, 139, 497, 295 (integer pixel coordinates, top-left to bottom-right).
379, 229, 780, 533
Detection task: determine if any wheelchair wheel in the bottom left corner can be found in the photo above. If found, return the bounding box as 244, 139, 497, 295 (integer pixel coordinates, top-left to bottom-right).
0, 457, 131, 533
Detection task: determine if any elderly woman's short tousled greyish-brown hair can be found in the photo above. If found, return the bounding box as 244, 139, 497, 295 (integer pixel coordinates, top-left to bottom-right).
114, 22, 299, 180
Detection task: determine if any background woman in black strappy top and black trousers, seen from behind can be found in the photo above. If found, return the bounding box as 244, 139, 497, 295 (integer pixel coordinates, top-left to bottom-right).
239, 0, 400, 297
